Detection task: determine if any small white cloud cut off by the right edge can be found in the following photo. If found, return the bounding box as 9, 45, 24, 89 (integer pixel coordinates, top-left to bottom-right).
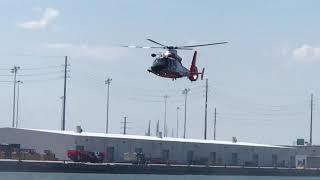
291, 44, 320, 61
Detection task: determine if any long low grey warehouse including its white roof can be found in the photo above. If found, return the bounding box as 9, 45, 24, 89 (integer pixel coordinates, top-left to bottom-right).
0, 128, 296, 167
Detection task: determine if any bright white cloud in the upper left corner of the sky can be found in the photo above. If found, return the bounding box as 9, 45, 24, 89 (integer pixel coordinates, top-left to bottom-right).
17, 8, 60, 30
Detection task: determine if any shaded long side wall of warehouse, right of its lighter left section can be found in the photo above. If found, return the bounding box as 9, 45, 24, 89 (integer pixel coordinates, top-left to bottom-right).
76, 136, 295, 167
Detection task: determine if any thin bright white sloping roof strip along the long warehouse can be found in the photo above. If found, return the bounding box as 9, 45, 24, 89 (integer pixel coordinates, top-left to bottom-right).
0, 128, 289, 148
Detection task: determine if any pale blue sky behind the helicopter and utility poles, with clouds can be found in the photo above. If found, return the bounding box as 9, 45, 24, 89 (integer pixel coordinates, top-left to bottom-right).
0, 0, 320, 144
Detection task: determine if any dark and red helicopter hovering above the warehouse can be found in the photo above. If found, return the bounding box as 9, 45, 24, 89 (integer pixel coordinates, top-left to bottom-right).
123, 39, 228, 82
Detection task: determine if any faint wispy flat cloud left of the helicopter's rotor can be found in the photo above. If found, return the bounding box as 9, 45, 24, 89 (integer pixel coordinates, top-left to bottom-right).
45, 43, 128, 61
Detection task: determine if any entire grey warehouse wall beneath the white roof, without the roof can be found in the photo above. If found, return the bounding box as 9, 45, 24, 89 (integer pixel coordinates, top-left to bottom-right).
0, 128, 295, 167
